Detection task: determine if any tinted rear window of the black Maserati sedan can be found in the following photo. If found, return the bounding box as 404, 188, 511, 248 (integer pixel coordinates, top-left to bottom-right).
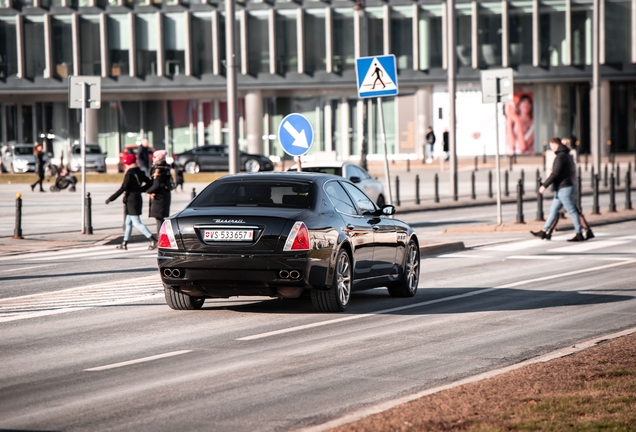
192, 181, 315, 208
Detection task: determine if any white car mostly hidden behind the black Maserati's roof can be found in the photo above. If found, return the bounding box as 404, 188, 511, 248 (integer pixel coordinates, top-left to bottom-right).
287, 161, 386, 208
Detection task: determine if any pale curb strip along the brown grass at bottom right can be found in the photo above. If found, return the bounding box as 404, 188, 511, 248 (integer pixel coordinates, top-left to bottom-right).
297, 327, 636, 432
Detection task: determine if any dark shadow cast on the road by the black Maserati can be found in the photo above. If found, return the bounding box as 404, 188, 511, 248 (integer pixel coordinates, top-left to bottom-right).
203, 287, 636, 317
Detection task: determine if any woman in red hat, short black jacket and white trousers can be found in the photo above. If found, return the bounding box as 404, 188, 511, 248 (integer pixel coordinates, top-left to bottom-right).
106, 154, 157, 250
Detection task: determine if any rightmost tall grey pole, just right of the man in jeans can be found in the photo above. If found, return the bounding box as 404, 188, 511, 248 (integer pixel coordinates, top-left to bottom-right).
591, 0, 601, 173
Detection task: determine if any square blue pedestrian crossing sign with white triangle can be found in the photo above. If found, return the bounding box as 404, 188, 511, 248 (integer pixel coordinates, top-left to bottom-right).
356, 54, 398, 98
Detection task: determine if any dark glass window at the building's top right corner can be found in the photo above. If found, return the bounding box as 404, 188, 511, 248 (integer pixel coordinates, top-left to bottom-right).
605, 0, 634, 64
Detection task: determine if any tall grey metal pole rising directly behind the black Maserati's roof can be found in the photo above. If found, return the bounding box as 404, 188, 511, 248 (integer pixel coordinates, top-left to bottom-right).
225, 0, 240, 174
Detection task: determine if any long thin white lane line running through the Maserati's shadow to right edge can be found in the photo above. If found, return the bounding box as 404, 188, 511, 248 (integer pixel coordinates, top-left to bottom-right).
236, 259, 636, 341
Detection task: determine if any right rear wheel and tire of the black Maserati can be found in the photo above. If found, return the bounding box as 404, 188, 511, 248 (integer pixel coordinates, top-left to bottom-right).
311, 249, 353, 312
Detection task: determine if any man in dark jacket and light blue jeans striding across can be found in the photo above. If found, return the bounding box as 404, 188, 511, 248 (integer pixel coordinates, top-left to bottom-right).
530, 138, 585, 242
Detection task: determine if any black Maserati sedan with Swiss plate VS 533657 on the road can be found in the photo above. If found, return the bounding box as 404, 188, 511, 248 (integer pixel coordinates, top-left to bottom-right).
157, 172, 420, 312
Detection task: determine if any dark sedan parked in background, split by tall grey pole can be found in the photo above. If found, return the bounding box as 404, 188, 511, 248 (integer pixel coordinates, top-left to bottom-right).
174, 144, 274, 174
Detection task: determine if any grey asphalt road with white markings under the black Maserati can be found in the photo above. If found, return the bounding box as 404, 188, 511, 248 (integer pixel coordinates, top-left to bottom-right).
0, 222, 636, 431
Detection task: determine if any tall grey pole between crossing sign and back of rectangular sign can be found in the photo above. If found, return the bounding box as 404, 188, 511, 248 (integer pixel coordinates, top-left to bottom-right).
446, 0, 458, 201
